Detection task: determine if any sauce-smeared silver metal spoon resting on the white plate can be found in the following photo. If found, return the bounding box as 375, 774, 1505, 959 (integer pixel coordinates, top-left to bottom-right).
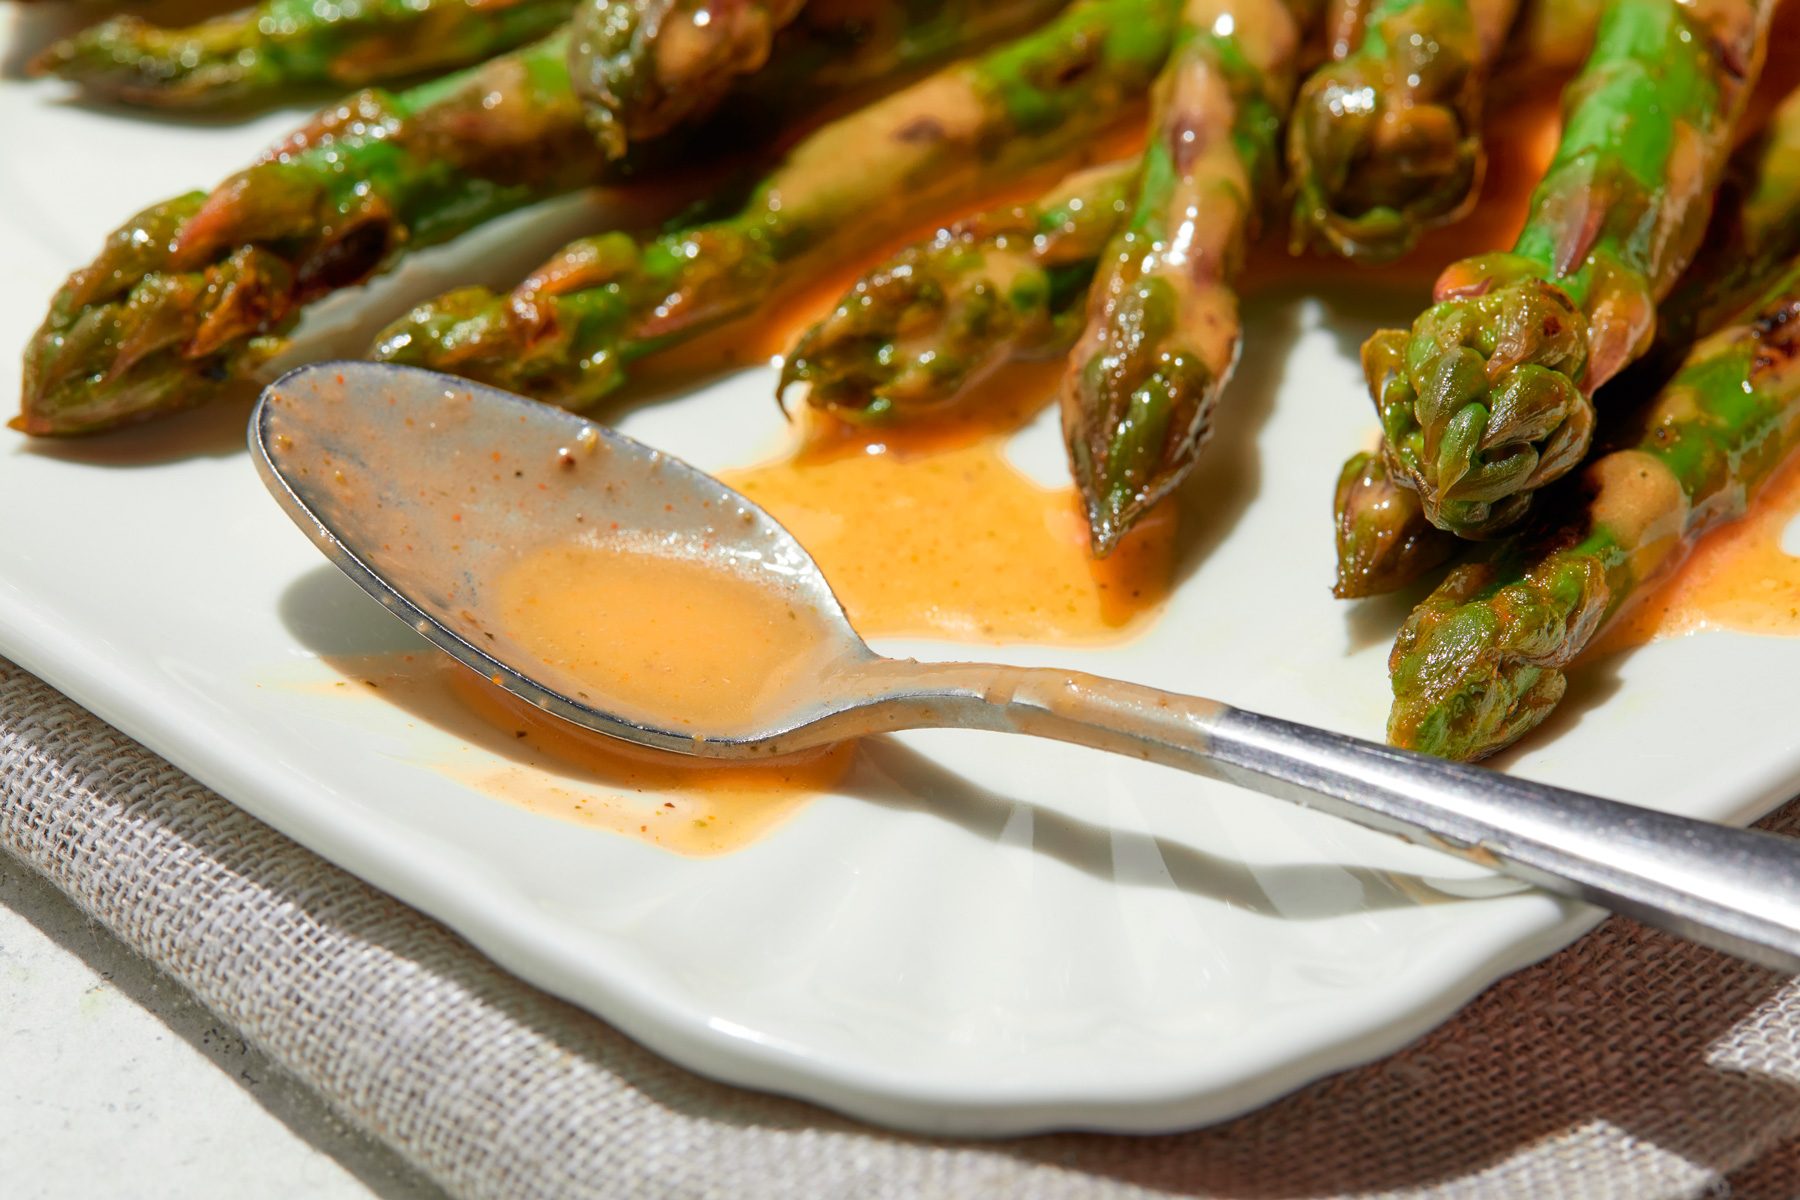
250, 362, 1800, 973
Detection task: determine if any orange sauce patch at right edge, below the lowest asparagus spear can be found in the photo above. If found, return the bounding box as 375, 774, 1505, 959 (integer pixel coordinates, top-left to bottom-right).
1589, 462, 1800, 657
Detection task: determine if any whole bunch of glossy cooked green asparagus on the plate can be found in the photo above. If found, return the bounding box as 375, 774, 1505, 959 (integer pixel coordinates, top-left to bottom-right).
16, 0, 1800, 770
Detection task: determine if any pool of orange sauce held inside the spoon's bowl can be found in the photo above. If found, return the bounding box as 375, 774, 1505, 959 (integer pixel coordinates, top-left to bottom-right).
493, 536, 841, 734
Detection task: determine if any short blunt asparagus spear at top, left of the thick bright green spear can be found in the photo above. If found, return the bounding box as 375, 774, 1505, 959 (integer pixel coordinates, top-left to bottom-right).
1287, 0, 1517, 261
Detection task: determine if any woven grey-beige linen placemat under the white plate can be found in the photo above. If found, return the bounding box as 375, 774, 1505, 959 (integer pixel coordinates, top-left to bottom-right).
0, 660, 1800, 1200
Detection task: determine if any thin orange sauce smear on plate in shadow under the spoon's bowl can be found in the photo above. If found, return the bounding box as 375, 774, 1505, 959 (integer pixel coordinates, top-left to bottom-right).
328, 653, 857, 856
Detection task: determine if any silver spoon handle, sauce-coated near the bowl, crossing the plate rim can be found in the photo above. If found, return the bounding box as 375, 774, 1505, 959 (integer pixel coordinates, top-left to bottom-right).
874, 664, 1800, 973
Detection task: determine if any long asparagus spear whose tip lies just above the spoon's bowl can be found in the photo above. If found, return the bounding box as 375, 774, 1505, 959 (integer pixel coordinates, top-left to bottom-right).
376, 0, 1175, 408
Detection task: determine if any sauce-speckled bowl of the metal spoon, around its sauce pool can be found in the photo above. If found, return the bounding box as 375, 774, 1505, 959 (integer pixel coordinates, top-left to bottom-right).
250, 362, 877, 759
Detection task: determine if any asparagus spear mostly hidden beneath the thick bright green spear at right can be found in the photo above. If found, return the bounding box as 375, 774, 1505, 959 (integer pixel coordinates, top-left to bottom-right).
1332, 77, 1800, 599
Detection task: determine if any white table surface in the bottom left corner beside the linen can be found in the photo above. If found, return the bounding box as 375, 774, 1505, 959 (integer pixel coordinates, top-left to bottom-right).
0, 855, 441, 1200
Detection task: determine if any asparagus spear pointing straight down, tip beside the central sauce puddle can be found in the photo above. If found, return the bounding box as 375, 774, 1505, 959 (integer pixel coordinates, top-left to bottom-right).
1060, 0, 1318, 556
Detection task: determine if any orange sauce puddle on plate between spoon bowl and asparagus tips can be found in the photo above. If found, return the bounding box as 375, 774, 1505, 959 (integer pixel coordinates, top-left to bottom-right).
724, 362, 1175, 644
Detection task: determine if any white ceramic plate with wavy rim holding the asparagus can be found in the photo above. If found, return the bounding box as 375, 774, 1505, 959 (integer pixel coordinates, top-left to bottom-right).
0, 37, 1800, 1133
